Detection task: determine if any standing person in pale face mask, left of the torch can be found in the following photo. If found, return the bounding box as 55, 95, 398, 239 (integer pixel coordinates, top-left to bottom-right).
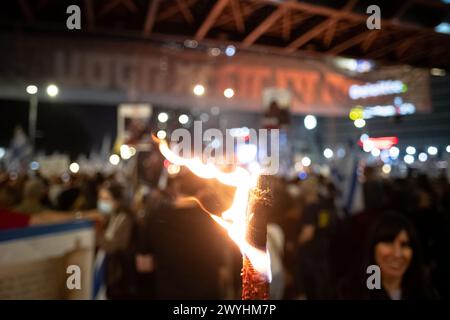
97, 183, 135, 299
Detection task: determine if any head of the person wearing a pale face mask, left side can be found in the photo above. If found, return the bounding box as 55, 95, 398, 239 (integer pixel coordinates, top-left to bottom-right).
97, 182, 125, 214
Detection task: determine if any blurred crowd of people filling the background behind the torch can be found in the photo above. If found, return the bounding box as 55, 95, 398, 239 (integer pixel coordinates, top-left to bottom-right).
0, 149, 450, 300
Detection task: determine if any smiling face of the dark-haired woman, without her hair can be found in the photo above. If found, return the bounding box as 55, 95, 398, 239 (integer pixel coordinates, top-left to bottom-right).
375, 230, 413, 279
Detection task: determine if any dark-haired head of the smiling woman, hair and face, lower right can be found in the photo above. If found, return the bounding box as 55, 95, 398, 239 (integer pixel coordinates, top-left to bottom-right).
366, 212, 423, 289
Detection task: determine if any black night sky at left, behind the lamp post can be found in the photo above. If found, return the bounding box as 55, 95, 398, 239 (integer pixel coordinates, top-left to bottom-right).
0, 100, 117, 159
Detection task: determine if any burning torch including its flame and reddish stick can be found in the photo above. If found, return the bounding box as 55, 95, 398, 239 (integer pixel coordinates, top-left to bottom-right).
153, 136, 271, 300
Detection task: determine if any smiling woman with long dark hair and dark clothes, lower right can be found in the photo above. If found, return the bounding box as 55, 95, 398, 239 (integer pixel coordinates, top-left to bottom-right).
338, 212, 438, 300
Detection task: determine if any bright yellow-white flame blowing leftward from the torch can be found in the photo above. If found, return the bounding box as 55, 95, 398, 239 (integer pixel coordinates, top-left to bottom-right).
154, 138, 271, 279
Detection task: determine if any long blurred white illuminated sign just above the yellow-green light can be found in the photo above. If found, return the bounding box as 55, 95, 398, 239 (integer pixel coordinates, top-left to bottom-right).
348, 80, 408, 100
